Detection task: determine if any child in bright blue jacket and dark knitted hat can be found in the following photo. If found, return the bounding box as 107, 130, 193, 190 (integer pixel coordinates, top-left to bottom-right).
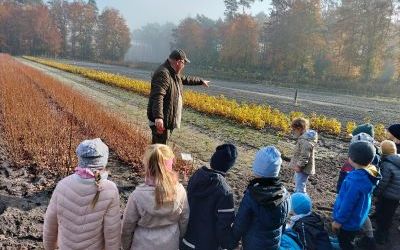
332, 141, 381, 250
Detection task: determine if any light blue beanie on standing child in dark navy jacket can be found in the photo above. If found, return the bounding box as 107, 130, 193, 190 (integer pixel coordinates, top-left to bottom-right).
253, 146, 282, 177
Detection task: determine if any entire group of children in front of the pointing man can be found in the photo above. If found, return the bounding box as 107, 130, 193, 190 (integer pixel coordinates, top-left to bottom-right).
43, 118, 400, 250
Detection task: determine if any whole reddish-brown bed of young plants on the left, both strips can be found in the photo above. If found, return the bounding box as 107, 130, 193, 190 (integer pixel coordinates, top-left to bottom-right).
0, 54, 194, 175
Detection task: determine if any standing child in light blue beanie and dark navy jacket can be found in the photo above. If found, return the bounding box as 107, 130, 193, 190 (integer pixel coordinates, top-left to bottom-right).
232, 146, 290, 250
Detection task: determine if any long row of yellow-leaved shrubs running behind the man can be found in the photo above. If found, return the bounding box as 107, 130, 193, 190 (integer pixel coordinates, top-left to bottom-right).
24, 56, 385, 140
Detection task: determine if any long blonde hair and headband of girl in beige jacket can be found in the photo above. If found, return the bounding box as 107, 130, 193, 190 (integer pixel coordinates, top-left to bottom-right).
143, 144, 178, 209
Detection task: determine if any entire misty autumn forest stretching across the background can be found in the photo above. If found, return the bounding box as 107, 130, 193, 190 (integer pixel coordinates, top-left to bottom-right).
0, 0, 400, 96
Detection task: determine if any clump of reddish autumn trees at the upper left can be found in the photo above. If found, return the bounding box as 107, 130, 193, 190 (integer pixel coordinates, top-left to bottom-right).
0, 0, 131, 61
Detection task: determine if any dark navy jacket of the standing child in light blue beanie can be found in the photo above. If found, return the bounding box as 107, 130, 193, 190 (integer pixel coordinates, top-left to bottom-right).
232, 178, 290, 250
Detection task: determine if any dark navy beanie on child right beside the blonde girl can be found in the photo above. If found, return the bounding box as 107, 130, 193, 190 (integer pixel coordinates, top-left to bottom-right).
210, 144, 237, 172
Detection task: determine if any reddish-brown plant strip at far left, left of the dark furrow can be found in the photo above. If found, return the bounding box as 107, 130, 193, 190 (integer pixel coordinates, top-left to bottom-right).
0, 54, 82, 170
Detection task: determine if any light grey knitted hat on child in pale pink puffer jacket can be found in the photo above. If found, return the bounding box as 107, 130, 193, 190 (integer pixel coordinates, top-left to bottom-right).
76, 138, 108, 168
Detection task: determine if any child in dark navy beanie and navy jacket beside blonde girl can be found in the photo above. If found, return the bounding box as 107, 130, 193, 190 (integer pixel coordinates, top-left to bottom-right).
179, 144, 237, 250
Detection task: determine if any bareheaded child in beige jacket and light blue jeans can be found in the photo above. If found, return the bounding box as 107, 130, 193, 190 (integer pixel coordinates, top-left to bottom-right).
289, 118, 318, 193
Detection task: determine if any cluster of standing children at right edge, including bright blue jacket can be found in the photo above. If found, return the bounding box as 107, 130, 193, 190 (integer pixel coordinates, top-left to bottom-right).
332, 123, 400, 249
